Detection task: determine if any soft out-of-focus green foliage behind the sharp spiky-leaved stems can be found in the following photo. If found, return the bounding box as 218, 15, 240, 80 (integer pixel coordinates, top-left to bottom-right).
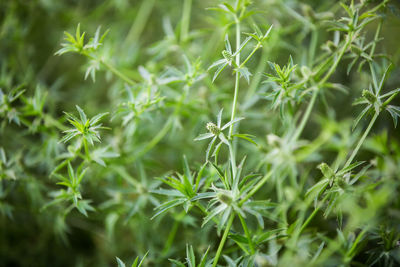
0, 0, 400, 266
